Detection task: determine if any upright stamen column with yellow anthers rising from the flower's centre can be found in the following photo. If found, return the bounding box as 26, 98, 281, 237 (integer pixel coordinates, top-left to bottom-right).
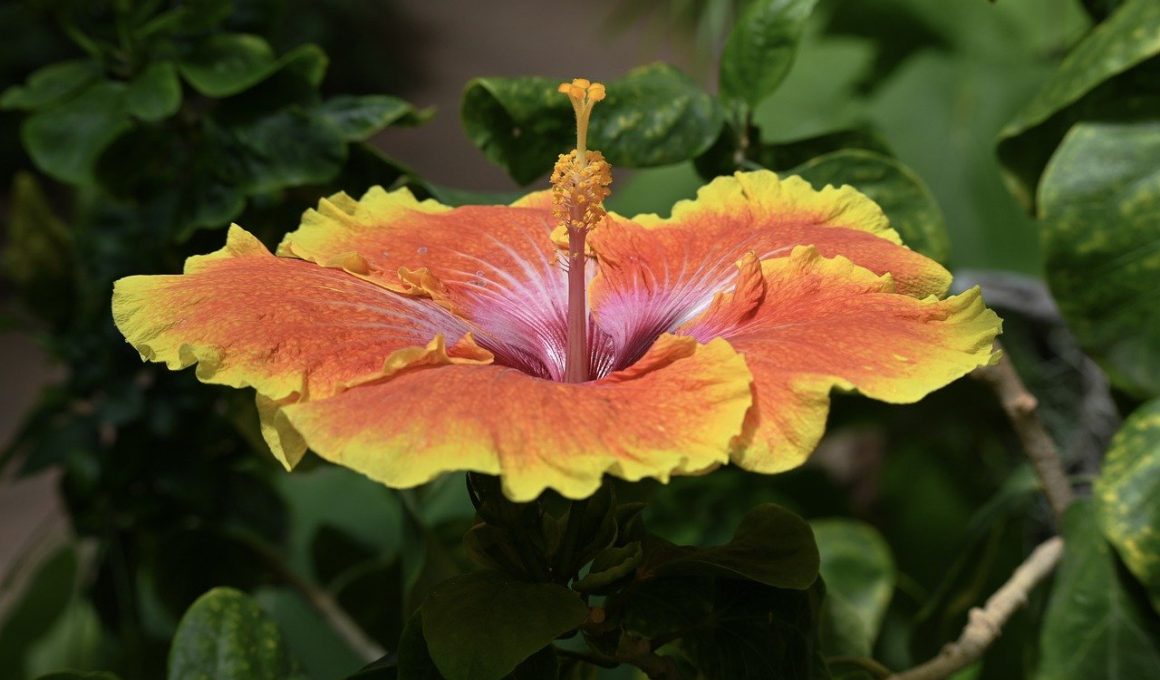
552, 78, 612, 383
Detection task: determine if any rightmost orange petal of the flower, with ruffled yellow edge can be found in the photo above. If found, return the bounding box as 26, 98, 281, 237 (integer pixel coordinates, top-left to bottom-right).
681, 247, 1001, 472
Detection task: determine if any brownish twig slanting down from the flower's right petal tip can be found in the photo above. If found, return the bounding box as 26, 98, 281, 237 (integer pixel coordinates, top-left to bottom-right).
974, 345, 1074, 521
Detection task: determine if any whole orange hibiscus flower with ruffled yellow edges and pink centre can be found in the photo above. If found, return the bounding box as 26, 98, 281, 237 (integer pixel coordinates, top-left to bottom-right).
113, 81, 1000, 500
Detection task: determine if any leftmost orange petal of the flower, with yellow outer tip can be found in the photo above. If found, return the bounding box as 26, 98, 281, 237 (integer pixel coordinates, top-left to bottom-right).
113, 226, 481, 402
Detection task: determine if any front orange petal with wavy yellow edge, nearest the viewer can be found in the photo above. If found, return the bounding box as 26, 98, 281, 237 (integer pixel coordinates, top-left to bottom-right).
282, 335, 751, 500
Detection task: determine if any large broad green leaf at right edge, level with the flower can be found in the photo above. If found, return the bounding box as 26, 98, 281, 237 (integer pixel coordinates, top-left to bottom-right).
1039, 114, 1160, 396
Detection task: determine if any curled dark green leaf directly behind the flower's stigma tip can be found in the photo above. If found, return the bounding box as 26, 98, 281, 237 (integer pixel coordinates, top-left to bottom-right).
461, 64, 722, 185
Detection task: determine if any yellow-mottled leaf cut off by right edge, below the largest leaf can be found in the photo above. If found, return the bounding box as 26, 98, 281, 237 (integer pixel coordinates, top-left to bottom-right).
1094, 399, 1160, 612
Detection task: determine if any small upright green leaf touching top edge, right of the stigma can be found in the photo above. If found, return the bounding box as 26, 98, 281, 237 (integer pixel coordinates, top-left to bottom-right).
720, 0, 817, 107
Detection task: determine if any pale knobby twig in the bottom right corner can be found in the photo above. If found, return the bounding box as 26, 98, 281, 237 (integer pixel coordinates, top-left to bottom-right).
890, 536, 1064, 680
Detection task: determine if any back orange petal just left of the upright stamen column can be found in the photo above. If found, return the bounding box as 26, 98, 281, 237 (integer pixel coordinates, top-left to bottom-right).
278, 187, 584, 377
